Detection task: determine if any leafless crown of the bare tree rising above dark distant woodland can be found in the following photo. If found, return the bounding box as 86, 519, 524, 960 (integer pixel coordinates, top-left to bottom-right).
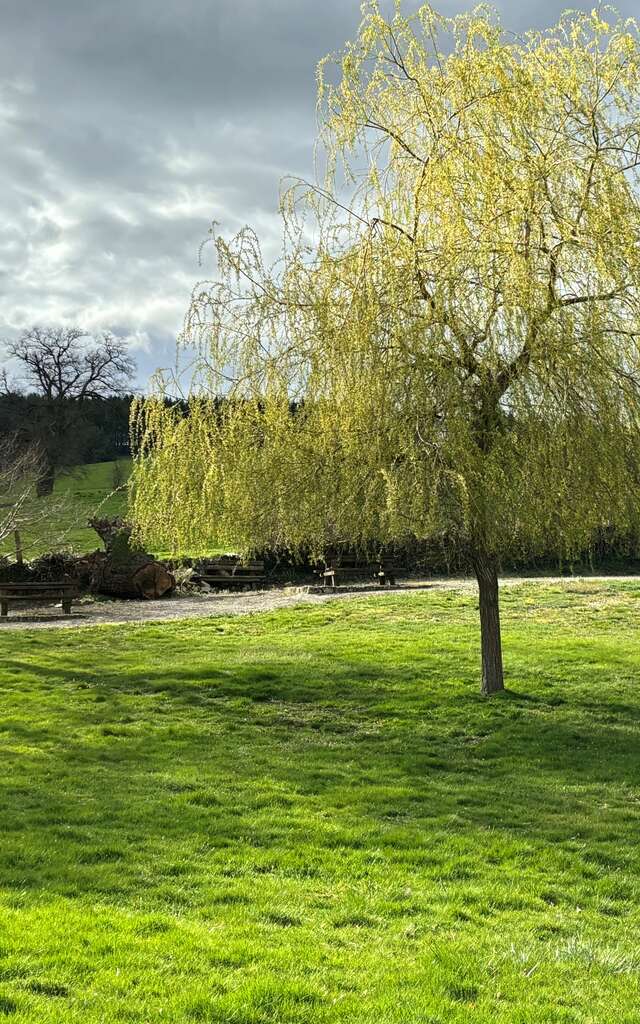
6, 327, 135, 400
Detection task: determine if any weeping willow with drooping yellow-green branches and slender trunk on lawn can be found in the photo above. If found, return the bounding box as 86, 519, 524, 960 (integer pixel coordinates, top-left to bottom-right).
133, 2, 640, 693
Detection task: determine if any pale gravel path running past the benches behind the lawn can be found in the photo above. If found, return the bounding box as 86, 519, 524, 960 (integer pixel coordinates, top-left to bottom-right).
0, 575, 640, 630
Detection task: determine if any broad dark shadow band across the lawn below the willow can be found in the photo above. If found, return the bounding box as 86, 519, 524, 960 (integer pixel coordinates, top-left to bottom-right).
0, 622, 640, 899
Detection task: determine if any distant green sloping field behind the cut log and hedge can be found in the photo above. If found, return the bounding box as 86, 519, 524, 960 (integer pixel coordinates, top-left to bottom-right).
0, 459, 131, 559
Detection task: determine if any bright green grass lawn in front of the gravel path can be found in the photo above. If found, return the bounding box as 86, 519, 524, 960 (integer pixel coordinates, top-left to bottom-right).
0, 581, 640, 1024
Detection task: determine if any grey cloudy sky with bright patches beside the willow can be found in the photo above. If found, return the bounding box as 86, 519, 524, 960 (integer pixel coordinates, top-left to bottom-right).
0, 0, 638, 386
